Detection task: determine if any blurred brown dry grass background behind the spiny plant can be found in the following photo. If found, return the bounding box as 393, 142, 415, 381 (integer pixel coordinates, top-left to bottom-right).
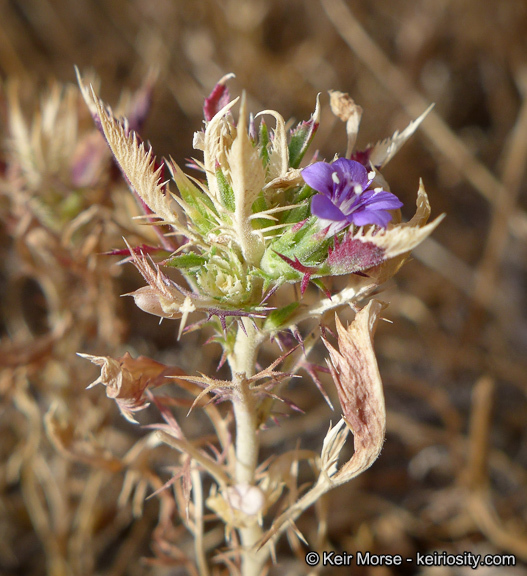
0, 0, 527, 576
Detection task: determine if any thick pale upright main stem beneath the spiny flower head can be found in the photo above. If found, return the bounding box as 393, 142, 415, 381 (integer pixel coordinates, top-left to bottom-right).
229, 318, 269, 576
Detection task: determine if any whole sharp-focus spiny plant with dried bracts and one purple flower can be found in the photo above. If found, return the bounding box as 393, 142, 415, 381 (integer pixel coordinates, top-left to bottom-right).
79, 76, 439, 575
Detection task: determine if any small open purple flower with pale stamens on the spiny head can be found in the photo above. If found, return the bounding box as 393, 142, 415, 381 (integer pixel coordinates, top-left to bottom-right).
302, 158, 403, 234
